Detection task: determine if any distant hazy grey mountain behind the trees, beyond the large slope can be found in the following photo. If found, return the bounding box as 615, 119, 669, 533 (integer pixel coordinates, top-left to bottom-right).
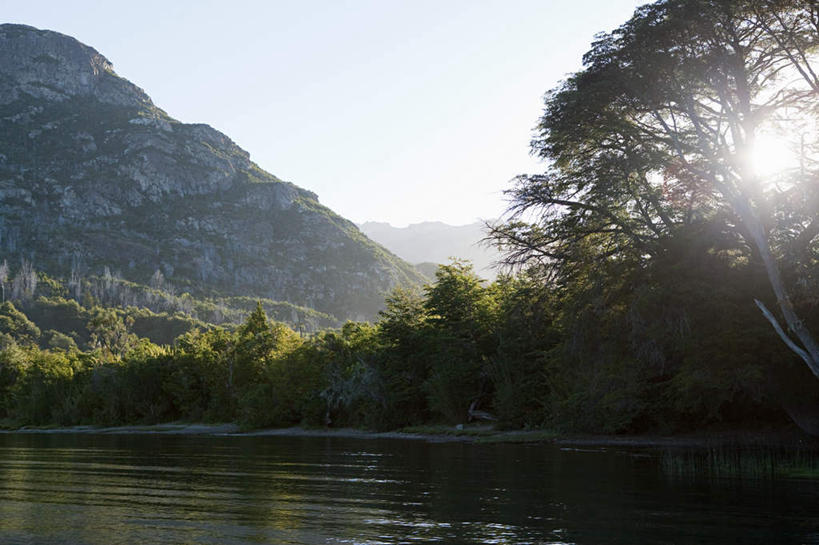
358, 221, 501, 280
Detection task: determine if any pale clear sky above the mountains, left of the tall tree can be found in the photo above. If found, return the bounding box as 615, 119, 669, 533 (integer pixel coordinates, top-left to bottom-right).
0, 0, 645, 226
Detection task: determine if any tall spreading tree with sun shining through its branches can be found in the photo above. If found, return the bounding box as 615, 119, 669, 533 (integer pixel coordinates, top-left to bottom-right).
493, 0, 819, 376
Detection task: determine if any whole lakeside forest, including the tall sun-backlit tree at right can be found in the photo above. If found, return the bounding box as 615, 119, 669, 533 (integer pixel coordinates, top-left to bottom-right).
0, 0, 819, 433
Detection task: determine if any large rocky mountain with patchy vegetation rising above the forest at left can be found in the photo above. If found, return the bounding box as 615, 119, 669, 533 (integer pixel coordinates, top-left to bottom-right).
0, 24, 421, 319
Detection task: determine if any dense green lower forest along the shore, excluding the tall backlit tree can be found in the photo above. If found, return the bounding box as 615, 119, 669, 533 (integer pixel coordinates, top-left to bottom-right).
0, 255, 816, 432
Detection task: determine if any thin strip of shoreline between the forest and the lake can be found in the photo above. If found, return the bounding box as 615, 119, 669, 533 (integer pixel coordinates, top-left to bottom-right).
0, 423, 819, 449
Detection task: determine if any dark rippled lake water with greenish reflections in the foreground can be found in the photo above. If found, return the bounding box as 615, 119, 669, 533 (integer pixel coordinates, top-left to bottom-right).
0, 434, 819, 545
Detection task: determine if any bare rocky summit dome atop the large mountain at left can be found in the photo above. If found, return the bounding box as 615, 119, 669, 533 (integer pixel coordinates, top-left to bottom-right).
0, 24, 151, 106
